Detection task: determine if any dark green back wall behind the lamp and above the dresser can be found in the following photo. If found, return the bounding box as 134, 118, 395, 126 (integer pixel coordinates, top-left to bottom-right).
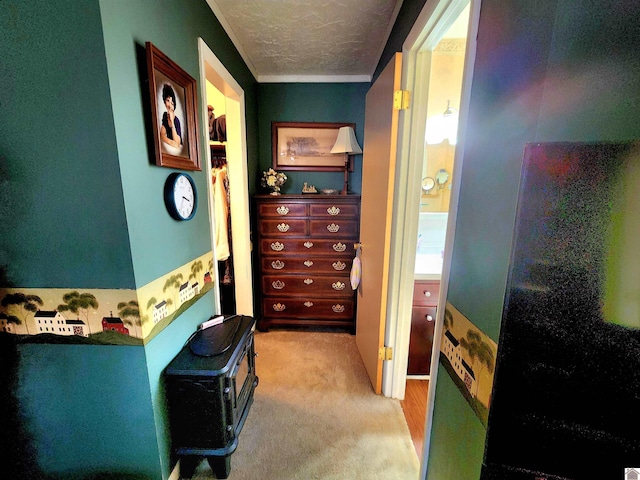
256, 83, 370, 193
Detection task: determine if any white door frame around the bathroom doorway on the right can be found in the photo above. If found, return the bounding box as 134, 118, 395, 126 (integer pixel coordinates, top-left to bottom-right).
383, 0, 481, 470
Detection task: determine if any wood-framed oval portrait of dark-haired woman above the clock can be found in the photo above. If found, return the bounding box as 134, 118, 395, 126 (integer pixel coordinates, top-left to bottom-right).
146, 42, 201, 170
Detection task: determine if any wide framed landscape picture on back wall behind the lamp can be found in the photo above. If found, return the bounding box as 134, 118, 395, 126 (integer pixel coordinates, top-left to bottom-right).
271, 122, 355, 172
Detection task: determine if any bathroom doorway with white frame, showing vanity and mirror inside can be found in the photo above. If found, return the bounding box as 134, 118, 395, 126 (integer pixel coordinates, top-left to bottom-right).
385, 0, 480, 472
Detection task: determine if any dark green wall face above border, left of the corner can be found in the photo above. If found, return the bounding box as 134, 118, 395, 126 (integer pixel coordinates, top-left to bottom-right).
0, 0, 135, 288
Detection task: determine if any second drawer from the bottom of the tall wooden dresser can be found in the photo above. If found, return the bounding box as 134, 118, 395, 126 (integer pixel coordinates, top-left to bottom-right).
262, 275, 353, 298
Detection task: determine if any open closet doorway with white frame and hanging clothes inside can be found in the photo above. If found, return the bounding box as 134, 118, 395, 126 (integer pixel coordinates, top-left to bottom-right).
198, 38, 253, 316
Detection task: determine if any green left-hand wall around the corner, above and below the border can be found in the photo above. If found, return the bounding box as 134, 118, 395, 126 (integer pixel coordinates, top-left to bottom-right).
0, 0, 258, 480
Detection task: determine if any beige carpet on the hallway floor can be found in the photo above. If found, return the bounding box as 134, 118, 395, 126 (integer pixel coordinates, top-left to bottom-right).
193, 331, 420, 480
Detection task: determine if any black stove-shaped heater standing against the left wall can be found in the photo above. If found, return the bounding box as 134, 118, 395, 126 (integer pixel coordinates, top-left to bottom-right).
164, 315, 258, 478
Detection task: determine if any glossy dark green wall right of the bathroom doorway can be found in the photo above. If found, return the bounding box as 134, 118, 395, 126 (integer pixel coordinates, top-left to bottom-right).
427, 0, 640, 480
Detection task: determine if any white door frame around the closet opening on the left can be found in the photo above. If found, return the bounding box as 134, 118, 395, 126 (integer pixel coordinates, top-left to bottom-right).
198, 38, 253, 316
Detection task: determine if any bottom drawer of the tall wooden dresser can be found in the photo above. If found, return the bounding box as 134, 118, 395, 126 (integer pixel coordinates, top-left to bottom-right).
262, 297, 355, 321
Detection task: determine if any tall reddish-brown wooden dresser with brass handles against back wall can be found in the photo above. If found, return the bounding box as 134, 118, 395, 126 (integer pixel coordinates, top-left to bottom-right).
254, 195, 360, 334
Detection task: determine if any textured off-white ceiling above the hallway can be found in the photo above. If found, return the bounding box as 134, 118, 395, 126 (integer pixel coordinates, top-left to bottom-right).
207, 0, 402, 82
